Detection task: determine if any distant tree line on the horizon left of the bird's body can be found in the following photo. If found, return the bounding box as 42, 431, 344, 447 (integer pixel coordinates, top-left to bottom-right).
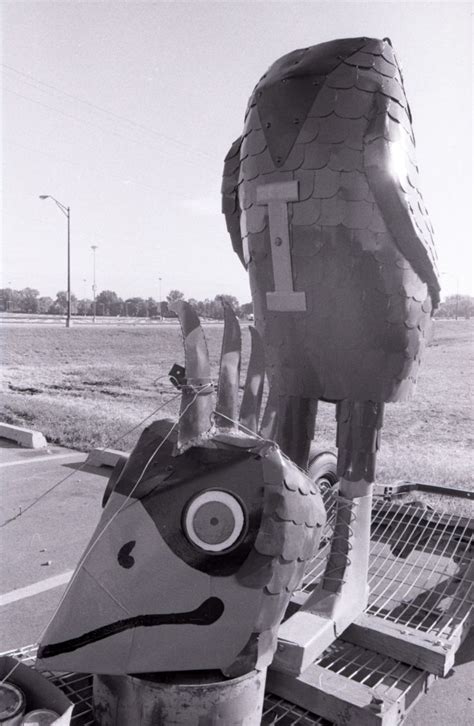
0, 287, 252, 320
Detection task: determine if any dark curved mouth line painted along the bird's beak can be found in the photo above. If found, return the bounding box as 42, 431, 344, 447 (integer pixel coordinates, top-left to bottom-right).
38, 597, 224, 659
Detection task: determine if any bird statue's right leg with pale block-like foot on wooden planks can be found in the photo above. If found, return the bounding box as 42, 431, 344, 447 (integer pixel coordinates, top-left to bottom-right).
272, 401, 383, 675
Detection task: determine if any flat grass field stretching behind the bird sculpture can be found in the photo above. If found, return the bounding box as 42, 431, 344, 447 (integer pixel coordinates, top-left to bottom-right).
0, 320, 474, 506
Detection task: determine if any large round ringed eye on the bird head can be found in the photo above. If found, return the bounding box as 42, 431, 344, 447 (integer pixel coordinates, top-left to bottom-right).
184, 489, 246, 552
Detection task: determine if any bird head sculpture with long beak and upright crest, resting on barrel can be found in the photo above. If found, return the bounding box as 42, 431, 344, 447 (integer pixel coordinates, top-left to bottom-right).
38, 302, 325, 676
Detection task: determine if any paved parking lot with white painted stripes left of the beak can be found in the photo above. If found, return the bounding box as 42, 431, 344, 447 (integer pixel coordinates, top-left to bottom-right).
0, 439, 107, 651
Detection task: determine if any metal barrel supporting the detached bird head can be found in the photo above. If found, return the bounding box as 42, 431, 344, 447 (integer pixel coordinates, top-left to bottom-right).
93, 669, 266, 726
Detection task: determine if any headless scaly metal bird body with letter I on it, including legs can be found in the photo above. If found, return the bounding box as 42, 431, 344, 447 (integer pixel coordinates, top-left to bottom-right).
222, 38, 440, 656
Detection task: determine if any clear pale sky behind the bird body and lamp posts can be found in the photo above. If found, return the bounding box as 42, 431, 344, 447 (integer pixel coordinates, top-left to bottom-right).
1, 0, 474, 303
